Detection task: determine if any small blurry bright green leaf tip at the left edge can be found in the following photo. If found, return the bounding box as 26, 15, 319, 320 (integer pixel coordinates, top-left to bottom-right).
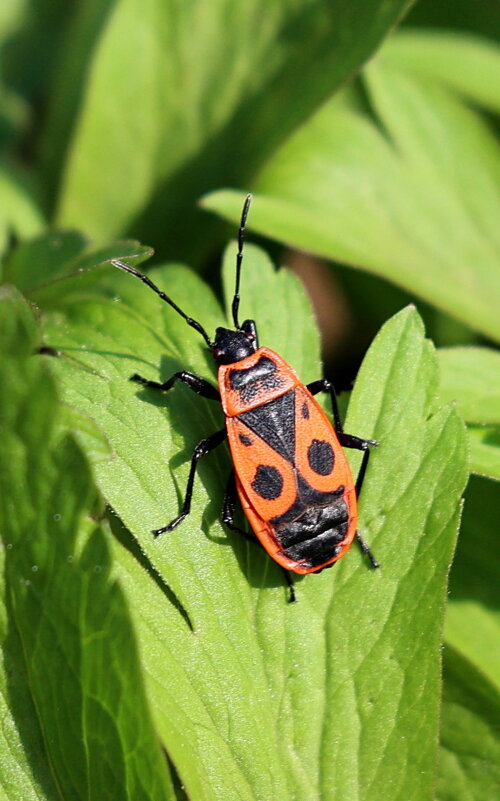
0, 164, 45, 253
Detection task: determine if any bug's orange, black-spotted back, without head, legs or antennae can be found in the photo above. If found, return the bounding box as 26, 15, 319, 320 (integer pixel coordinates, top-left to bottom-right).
219, 348, 357, 573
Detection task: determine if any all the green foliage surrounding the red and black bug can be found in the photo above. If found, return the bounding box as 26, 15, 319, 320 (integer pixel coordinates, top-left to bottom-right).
0, 0, 500, 801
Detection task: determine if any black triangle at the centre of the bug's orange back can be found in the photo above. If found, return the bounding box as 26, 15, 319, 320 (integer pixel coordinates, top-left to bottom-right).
238, 389, 295, 464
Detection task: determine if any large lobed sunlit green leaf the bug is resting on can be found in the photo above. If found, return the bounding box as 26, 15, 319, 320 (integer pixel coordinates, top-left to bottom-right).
39, 248, 467, 801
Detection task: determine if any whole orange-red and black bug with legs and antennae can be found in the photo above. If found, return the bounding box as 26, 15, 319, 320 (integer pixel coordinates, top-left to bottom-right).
112, 195, 378, 597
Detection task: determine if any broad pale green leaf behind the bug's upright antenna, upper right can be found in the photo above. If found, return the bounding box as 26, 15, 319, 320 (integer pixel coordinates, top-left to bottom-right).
204, 33, 500, 339
